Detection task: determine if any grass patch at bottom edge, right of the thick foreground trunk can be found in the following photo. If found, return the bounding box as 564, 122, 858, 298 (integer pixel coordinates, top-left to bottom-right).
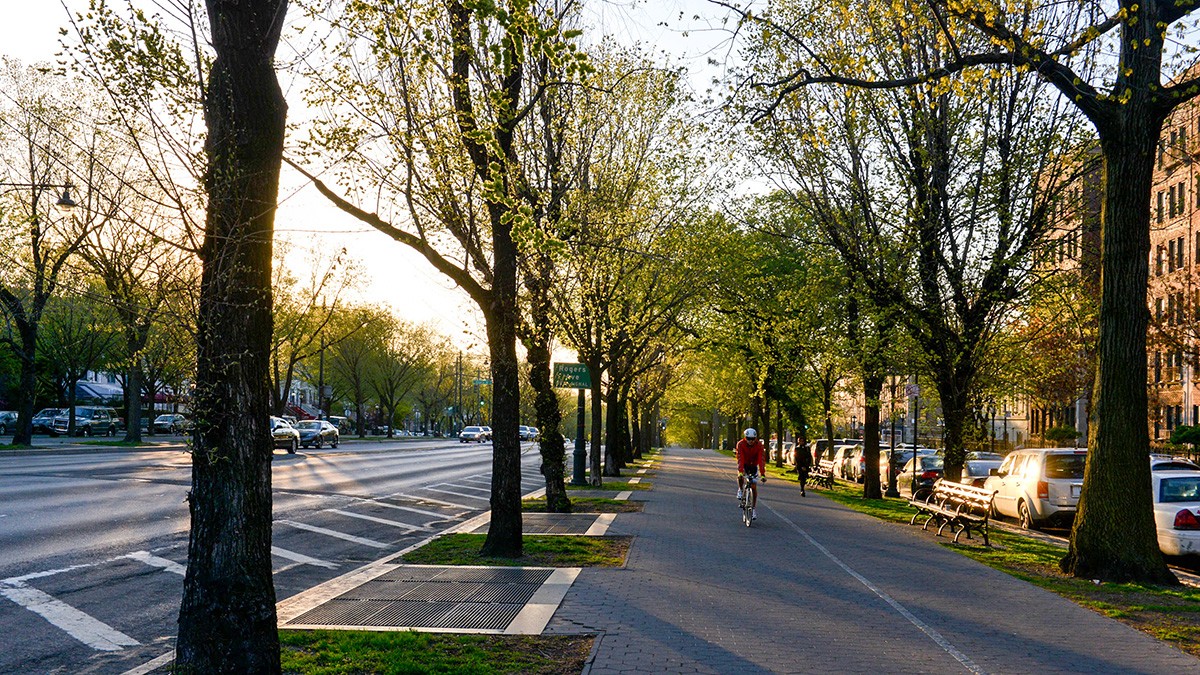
280, 631, 594, 675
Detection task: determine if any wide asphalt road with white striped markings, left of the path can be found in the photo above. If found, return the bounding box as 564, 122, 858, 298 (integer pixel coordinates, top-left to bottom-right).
0, 440, 542, 674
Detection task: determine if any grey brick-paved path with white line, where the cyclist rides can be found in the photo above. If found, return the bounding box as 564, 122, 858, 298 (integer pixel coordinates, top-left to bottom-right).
546, 448, 1200, 675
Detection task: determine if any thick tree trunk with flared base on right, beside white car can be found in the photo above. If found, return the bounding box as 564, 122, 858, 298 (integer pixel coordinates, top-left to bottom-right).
1062, 111, 1178, 584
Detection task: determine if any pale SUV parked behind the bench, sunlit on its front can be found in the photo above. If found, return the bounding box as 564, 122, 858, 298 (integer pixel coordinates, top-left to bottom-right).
984, 448, 1087, 530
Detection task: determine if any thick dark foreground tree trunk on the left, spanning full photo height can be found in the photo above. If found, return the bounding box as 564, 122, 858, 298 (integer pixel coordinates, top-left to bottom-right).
175, 0, 287, 674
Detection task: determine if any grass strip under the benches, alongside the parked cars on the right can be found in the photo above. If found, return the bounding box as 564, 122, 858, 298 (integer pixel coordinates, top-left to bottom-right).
796, 473, 1200, 657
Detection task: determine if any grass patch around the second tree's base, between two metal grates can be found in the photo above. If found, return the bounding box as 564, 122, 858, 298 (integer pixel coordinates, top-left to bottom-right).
404, 534, 631, 567
